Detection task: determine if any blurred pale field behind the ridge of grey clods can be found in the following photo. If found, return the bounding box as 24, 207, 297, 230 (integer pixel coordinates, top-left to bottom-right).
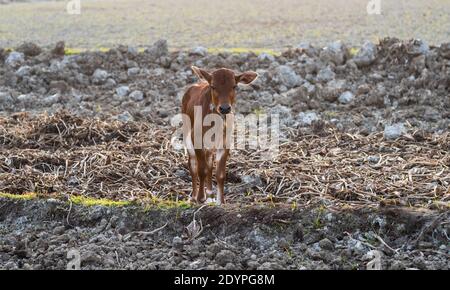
0, 0, 450, 50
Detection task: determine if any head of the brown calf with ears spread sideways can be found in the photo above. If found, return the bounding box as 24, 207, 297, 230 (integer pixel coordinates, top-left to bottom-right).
192, 66, 258, 115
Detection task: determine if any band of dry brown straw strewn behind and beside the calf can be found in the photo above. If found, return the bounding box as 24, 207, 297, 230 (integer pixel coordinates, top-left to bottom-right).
0, 112, 450, 209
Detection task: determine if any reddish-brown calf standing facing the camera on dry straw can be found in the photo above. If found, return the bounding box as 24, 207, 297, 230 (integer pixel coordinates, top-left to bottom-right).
182, 67, 257, 204
